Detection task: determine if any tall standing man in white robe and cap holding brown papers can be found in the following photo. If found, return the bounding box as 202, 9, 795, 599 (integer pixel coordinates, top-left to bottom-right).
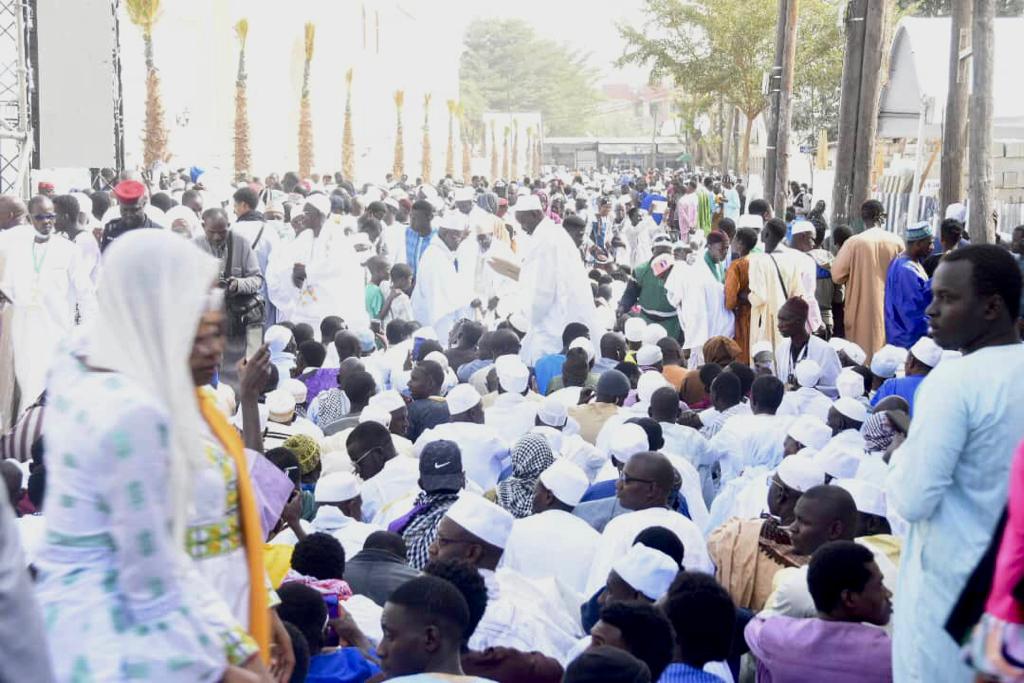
515, 195, 600, 366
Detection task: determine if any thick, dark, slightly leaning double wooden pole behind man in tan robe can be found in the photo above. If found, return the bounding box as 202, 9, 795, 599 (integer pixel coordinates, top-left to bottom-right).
831, 0, 892, 225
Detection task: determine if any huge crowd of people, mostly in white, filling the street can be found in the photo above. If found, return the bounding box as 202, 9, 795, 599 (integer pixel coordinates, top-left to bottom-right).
0, 162, 1024, 683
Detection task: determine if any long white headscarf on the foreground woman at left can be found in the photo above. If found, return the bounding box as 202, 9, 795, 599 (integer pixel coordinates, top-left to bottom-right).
88, 230, 219, 548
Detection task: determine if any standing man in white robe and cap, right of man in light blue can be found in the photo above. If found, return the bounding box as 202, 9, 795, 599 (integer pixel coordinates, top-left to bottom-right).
413, 211, 474, 346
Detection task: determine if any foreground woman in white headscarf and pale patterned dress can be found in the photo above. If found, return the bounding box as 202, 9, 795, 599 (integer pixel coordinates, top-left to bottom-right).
36, 230, 265, 682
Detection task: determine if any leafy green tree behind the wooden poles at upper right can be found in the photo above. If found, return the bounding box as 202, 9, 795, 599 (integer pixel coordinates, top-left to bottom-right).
618, 0, 843, 173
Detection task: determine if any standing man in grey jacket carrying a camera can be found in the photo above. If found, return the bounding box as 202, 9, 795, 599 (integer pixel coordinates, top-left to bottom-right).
193, 202, 265, 383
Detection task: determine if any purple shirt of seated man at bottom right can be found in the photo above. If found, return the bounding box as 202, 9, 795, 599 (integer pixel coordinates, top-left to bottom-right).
743, 616, 893, 683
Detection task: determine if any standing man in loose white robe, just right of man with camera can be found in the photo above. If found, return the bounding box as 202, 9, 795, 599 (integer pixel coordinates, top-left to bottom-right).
266, 195, 370, 333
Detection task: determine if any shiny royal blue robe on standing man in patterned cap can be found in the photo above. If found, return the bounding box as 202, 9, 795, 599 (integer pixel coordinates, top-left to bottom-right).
885, 256, 932, 348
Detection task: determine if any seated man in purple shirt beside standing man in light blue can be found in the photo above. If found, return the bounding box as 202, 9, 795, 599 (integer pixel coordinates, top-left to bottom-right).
744, 541, 893, 683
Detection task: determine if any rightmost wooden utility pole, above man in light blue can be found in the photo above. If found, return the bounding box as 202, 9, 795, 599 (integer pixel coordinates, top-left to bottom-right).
968, 0, 995, 245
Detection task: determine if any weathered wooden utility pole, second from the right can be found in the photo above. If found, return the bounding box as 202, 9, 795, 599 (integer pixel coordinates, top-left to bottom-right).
939, 0, 974, 215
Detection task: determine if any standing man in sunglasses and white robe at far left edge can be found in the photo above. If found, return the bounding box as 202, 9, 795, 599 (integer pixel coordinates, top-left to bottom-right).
0, 195, 96, 405
